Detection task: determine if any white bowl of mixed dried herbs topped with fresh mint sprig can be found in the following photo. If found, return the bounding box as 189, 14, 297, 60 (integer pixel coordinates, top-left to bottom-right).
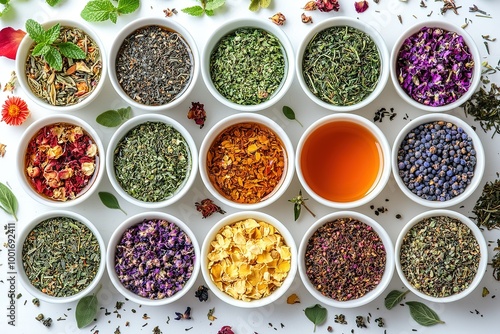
16, 19, 107, 111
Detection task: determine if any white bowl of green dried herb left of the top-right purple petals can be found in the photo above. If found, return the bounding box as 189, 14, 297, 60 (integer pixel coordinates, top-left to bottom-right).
296, 17, 389, 112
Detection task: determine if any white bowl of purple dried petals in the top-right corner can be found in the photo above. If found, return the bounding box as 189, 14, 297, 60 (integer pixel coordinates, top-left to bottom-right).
391, 21, 481, 112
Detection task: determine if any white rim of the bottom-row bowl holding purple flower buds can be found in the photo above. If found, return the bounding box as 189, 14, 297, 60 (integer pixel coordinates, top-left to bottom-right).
106, 211, 201, 306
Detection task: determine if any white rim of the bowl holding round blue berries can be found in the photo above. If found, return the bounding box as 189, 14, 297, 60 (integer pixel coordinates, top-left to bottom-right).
391, 113, 486, 209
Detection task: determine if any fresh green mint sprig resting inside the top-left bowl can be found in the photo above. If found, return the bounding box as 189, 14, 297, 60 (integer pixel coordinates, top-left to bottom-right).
26, 19, 86, 71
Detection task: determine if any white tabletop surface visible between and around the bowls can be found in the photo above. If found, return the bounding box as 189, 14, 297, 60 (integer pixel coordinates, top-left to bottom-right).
0, 0, 500, 334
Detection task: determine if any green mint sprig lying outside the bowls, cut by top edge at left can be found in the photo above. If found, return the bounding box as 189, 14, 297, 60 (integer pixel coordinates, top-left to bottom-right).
80, 0, 140, 23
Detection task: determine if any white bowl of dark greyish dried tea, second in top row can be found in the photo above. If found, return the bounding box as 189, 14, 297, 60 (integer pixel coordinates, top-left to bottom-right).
108, 17, 199, 111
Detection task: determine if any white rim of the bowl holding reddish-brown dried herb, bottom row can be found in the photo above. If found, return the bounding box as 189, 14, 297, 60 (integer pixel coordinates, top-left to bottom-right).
298, 211, 394, 308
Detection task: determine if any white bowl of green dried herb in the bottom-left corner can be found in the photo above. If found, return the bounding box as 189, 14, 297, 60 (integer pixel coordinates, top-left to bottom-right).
16, 210, 106, 303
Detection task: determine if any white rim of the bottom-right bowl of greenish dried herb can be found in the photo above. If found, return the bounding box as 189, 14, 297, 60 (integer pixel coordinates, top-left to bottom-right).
394, 209, 488, 303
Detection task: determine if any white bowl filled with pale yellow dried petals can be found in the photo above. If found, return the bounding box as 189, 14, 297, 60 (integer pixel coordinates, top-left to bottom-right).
201, 211, 297, 308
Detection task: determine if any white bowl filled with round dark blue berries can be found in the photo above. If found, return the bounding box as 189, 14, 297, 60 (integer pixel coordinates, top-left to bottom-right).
392, 114, 485, 208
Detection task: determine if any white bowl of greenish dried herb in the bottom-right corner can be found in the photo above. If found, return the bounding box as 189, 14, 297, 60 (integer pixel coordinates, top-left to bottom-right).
396, 209, 488, 303
